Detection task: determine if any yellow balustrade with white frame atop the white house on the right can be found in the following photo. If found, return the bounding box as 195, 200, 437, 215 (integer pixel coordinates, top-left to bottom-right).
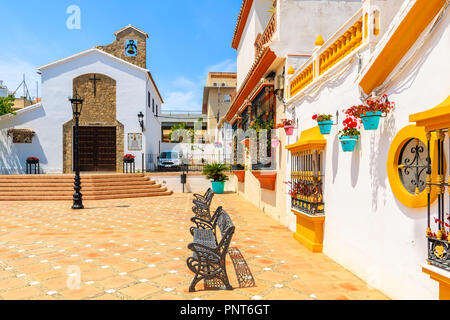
288, 9, 364, 98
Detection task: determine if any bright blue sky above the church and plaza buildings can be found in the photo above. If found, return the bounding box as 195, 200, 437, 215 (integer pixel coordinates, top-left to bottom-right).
0, 0, 241, 110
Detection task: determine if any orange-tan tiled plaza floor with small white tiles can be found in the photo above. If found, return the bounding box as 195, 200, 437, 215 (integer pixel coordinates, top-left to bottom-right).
0, 194, 387, 300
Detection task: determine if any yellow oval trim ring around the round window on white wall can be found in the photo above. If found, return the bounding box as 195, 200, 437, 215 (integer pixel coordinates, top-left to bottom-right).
387, 125, 438, 208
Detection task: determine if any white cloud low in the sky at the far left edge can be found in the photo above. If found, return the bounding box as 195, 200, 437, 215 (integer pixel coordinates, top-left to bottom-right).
0, 58, 41, 97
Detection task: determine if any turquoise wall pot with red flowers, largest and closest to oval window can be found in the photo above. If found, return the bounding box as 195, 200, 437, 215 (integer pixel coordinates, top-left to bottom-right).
345, 95, 395, 130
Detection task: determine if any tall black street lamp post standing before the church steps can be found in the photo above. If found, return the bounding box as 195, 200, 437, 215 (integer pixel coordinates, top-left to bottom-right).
69, 91, 84, 210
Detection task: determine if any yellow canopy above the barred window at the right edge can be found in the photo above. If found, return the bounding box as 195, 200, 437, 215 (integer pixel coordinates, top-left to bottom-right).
409, 96, 450, 132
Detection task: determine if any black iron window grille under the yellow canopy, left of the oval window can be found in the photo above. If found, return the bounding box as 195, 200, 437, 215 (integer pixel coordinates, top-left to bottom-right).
290, 150, 324, 215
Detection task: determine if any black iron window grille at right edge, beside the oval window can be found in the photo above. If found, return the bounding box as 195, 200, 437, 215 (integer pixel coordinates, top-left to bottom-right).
426, 130, 450, 271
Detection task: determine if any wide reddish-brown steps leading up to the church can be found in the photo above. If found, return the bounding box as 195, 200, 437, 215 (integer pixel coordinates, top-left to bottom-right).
0, 174, 172, 201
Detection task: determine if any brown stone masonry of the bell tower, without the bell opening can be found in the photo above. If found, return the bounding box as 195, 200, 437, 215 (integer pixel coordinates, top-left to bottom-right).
96, 28, 147, 69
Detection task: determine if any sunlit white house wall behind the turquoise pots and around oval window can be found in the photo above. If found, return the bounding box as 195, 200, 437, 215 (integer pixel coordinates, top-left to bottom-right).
288, 9, 450, 299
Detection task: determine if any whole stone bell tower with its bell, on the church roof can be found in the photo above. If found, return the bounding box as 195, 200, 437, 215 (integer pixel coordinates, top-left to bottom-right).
96, 25, 148, 69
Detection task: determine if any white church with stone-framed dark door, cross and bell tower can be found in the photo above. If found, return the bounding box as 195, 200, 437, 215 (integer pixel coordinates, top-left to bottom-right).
0, 25, 164, 174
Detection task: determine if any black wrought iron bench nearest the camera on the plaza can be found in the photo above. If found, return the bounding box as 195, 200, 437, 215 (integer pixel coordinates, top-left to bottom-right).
186, 211, 236, 292
